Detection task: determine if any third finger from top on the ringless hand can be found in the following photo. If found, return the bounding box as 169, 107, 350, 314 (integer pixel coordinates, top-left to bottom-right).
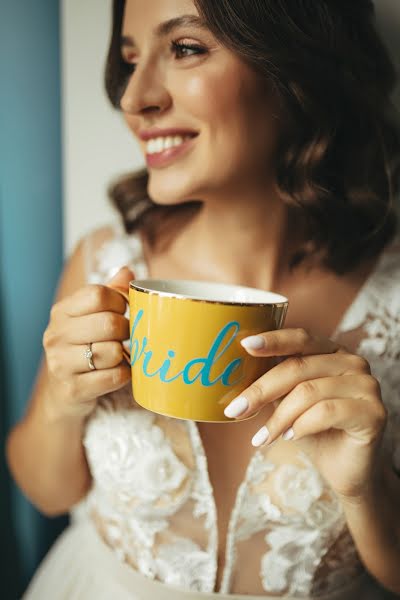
253, 375, 381, 445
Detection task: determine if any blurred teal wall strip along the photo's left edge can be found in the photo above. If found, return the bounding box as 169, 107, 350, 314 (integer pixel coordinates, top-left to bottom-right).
0, 0, 64, 600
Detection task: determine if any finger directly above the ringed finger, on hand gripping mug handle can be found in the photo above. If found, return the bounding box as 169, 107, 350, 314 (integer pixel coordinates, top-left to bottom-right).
65, 312, 129, 344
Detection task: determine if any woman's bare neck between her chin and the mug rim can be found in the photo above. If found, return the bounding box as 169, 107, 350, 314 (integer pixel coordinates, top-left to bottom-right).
170, 179, 304, 291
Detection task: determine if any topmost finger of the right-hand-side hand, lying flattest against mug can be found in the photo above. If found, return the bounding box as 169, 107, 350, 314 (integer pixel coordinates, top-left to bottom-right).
240, 328, 341, 356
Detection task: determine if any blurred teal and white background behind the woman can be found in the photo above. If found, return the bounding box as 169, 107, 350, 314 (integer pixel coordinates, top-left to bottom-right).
0, 0, 400, 600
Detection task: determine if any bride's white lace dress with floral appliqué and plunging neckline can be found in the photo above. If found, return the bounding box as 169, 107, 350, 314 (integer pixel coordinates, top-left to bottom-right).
24, 221, 400, 600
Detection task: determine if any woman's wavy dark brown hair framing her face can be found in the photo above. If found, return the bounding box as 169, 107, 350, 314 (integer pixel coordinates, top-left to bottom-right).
106, 0, 400, 274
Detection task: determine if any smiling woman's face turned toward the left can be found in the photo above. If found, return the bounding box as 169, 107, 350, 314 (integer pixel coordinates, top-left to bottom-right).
121, 0, 277, 204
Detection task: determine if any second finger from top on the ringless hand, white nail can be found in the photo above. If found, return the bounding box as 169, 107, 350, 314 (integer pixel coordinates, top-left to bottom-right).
225, 352, 371, 418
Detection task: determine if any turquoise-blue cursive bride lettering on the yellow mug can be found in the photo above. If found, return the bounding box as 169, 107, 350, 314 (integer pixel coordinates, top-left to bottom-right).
130, 309, 243, 387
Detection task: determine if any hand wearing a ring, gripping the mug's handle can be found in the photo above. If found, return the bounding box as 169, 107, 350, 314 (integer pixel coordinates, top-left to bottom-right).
43, 267, 134, 419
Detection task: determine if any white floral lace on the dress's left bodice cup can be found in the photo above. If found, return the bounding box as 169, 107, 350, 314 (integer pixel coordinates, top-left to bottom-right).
84, 388, 215, 591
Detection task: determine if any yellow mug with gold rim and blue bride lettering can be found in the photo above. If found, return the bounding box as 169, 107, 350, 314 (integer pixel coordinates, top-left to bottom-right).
114, 279, 288, 422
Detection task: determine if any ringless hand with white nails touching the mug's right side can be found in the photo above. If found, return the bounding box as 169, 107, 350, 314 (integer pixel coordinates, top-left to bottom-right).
225, 329, 387, 500
